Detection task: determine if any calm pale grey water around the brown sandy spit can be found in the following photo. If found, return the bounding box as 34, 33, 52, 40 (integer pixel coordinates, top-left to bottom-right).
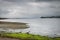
0, 18, 60, 37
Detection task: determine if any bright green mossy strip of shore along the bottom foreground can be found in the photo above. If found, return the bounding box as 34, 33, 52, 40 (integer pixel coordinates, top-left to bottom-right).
0, 33, 60, 40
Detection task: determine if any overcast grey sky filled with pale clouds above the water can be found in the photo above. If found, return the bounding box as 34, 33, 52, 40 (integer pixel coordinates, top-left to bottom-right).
0, 0, 60, 18
